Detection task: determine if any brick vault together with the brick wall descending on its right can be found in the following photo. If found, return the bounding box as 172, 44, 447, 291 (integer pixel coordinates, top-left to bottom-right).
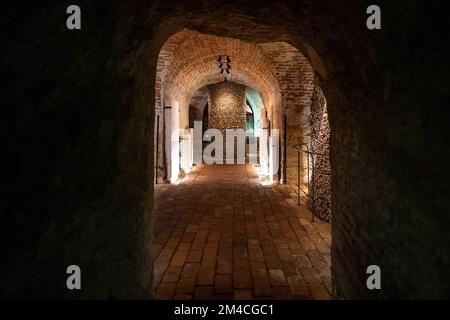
155, 34, 314, 184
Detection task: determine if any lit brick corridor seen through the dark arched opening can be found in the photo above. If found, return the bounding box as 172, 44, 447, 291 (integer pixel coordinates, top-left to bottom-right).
152, 29, 333, 300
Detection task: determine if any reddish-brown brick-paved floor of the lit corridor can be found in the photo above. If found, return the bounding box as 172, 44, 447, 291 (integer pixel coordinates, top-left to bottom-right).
153, 165, 331, 299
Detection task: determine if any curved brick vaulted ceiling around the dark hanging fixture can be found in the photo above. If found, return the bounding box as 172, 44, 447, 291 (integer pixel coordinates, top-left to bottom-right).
156, 29, 312, 115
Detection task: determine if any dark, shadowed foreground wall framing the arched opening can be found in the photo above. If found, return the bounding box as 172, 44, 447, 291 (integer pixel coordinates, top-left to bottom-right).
1, 0, 450, 298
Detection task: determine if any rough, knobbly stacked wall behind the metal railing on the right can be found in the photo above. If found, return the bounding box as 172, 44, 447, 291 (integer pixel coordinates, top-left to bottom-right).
308, 83, 331, 222
